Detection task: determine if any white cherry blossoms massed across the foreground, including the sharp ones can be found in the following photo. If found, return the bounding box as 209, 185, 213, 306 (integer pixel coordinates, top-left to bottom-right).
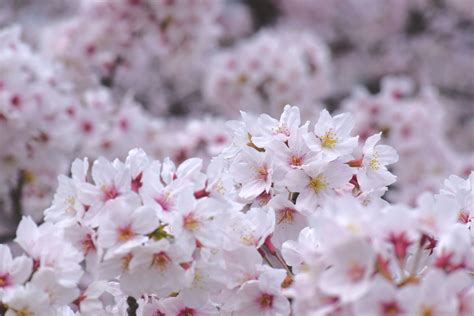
0, 105, 474, 315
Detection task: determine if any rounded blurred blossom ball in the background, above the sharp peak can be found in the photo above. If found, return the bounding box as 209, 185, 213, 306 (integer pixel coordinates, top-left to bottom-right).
203, 30, 331, 115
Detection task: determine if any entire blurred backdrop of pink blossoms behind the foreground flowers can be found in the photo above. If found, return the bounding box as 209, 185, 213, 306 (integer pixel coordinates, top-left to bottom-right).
0, 0, 474, 241
